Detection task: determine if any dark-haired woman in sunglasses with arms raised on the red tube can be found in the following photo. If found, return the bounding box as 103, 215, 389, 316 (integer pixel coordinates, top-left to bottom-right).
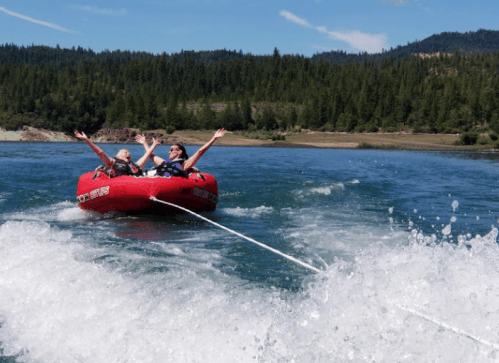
135, 129, 225, 177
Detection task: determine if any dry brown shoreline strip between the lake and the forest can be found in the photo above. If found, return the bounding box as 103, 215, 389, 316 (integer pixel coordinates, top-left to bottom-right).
0, 126, 494, 151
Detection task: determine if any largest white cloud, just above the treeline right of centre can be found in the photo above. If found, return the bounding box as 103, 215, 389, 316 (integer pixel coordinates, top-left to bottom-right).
316, 26, 390, 53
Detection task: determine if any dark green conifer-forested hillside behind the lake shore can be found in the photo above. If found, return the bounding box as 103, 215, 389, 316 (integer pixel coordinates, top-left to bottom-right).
0, 30, 499, 133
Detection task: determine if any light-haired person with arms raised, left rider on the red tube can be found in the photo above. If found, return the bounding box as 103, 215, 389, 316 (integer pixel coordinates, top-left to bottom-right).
75, 131, 154, 178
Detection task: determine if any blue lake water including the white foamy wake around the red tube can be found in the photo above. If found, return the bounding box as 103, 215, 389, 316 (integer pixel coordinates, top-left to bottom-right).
0, 143, 499, 363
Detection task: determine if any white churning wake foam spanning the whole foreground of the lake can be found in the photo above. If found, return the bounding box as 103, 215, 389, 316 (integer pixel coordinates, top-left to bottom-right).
0, 221, 499, 363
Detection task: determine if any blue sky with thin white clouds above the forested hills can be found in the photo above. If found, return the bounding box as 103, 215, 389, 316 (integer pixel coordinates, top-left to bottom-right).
0, 0, 499, 56
